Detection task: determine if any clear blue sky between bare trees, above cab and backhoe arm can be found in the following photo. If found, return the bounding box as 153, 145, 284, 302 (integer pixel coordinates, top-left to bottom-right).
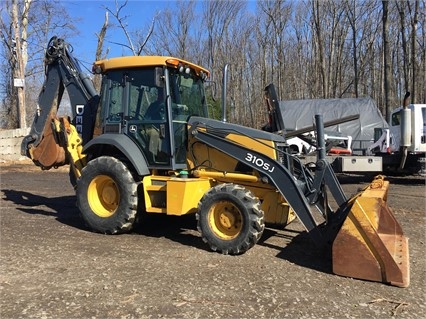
61, 0, 175, 68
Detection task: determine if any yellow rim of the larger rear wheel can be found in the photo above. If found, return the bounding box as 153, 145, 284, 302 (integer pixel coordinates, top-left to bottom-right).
87, 175, 120, 217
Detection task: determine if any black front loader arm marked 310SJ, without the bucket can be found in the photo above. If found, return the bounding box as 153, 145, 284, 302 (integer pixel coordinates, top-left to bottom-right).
189, 117, 356, 247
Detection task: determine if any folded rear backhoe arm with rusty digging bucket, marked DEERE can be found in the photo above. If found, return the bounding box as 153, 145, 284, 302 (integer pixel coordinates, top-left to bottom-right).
21, 37, 99, 169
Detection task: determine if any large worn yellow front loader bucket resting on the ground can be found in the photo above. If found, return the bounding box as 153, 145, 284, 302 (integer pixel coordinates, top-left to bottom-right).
332, 176, 410, 287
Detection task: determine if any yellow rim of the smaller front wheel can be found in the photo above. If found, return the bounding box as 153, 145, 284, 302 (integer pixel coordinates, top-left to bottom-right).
208, 201, 243, 240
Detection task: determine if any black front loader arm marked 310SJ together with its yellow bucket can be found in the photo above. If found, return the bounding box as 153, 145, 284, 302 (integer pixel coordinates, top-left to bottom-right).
188, 115, 410, 287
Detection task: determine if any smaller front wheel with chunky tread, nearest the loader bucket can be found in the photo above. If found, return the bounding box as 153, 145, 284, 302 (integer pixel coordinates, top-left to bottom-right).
196, 184, 265, 255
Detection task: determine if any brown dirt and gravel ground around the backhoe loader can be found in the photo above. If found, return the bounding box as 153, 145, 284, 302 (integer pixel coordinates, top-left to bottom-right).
0, 162, 426, 319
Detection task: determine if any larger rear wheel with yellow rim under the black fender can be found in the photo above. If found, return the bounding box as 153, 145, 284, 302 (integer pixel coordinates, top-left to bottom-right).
77, 156, 138, 234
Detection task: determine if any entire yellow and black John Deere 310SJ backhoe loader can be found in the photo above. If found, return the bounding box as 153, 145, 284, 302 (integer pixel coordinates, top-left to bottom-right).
22, 37, 409, 287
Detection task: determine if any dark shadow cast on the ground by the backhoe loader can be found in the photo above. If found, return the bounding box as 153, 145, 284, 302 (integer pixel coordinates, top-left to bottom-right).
2, 189, 331, 273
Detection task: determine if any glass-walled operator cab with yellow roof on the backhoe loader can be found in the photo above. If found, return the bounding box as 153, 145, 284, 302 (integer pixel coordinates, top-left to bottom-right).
95, 57, 208, 170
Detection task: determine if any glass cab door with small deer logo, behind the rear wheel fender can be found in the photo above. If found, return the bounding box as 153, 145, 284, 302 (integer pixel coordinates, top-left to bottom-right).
100, 68, 172, 169
